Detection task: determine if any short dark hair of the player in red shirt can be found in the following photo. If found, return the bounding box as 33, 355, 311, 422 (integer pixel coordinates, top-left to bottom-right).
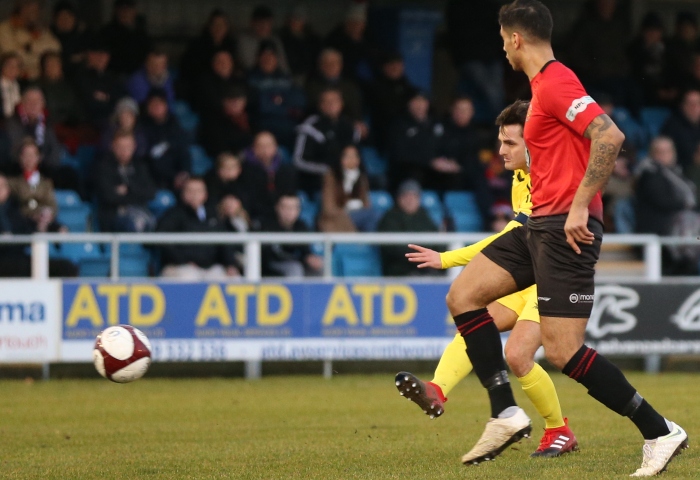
498, 0, 553, 42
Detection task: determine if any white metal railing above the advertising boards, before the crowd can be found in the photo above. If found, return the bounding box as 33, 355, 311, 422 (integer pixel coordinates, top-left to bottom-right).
0, 233, 688, 282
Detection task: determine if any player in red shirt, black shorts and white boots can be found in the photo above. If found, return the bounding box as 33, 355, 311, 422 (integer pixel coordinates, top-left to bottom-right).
447, 0, 688, 476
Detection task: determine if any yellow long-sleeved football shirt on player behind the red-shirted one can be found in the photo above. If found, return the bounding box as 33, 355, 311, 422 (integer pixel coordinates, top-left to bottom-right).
440, 170, 532, 268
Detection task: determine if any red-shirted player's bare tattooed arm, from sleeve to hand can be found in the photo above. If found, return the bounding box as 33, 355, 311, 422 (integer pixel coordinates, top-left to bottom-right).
564, 114, 625, 253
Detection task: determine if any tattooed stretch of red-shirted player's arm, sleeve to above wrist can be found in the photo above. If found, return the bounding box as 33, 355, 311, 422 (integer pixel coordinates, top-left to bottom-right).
582, 113, 625, 191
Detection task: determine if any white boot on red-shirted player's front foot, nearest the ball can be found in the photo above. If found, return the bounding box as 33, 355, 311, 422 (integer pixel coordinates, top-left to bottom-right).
462, 407, 532, 465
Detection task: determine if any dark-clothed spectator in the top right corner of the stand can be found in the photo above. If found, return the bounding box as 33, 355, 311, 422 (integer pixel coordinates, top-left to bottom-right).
666, 12, 700, 89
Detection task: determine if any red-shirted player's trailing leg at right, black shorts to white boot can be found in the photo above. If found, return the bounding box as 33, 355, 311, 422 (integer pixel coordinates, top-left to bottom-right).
528, 218, 688, 476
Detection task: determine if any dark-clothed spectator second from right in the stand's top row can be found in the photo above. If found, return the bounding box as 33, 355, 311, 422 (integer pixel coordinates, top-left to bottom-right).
628, 12, 673, 105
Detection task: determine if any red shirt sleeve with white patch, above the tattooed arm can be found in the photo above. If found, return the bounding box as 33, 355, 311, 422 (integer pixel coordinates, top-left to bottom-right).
540, 72, 605, 136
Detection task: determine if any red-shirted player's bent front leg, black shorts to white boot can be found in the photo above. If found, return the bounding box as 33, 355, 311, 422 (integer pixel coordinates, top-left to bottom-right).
447, 227, 534, 464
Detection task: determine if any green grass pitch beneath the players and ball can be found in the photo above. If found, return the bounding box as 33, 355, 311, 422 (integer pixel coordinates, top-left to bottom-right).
0, 373, 700, 480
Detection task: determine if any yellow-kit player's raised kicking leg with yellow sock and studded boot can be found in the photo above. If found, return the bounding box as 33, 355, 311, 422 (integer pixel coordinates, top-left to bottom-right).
395, 302, 525, 419
